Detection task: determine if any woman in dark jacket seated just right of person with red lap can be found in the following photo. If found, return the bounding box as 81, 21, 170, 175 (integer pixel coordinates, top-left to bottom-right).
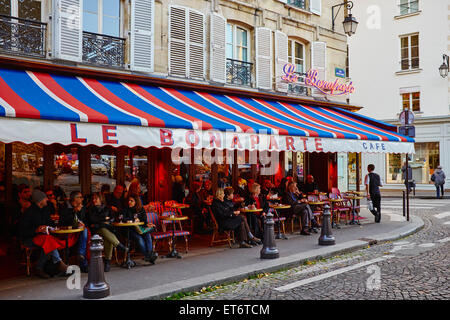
59, 191, 88, 272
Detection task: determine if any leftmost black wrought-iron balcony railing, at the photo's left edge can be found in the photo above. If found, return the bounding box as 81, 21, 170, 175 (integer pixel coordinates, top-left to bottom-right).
0, 15, 47, 58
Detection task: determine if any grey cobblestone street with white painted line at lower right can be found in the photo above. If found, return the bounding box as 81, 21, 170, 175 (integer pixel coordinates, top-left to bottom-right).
183, 199, 450, 300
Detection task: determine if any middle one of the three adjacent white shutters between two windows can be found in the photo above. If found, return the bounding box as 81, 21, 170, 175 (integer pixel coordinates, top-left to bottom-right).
188, 9, 205, 80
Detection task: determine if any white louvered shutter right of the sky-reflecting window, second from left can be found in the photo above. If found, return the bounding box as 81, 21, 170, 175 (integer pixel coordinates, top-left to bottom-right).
130, 0, 155, 72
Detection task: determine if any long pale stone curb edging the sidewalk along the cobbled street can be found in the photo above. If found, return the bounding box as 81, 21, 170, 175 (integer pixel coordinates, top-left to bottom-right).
102, 216, 424, 300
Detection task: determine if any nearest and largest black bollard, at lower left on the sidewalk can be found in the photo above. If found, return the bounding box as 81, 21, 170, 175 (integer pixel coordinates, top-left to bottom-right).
83, 234, 110, 299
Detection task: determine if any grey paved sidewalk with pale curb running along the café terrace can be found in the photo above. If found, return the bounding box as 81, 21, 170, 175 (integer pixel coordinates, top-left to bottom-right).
0, 209, 423, 300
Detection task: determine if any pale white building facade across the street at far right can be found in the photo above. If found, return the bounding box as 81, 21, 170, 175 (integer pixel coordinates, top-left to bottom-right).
349, 0, 450, 190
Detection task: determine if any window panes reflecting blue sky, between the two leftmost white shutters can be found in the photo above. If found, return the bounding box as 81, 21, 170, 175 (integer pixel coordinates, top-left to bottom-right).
83, 0, 120, 37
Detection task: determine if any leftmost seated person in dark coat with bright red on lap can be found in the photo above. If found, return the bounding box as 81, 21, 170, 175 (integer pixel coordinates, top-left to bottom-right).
20, 189, 67, 278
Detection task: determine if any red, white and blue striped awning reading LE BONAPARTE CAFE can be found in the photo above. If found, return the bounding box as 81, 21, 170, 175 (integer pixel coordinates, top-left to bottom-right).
0, 69, 414, 153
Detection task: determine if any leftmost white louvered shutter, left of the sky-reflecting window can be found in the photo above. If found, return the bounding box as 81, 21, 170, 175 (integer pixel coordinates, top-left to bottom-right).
53, 0, 83, 62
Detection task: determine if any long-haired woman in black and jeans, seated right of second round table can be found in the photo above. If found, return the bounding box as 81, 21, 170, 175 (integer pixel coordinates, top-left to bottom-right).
123, 194, 158, 264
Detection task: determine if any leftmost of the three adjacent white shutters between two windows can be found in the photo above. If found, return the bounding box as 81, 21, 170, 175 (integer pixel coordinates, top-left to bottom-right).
169, 6, 188, 77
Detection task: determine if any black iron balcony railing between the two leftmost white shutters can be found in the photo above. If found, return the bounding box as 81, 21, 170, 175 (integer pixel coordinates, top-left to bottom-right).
83, 31, 125, 68
